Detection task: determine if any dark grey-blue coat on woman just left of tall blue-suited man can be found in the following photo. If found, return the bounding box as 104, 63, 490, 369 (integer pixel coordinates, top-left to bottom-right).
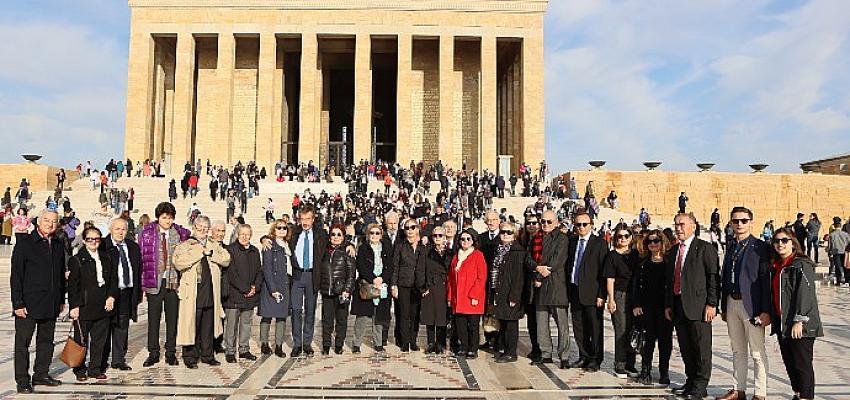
257, 241, 292, 318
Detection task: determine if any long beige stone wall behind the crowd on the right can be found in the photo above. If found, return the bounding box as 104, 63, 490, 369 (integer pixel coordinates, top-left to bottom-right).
567, 170, 850, 230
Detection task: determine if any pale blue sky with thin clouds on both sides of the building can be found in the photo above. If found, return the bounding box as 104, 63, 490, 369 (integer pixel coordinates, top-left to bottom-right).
0, 0, 850, 172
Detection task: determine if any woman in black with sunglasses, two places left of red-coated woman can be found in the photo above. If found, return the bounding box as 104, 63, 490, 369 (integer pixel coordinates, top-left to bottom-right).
391, 219, 427, 353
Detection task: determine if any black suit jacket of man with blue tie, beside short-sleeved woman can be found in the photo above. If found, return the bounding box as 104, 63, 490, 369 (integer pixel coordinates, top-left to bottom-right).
567, 235, 608, 306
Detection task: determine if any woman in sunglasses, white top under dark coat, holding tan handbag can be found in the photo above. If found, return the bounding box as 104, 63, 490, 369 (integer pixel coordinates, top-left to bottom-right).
351, 223, 393, 354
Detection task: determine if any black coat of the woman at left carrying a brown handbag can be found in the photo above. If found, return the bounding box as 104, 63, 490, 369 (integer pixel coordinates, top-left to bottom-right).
68, 248, 119, 321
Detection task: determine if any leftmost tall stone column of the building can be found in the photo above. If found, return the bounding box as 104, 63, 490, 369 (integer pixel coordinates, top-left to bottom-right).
124, 29, 156, 162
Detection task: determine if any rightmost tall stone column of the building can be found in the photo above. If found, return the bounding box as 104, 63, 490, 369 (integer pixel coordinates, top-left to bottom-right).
521, 33, 545, 171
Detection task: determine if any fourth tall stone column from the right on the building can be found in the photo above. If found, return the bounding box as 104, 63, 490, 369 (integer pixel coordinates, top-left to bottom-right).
395, 33, 412, 167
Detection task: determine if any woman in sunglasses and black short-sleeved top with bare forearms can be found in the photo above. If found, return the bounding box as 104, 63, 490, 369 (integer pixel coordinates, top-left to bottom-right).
602, 222, 640, 378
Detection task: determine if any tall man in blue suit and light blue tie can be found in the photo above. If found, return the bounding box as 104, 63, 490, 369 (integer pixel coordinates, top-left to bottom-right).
289, 205, 328, 357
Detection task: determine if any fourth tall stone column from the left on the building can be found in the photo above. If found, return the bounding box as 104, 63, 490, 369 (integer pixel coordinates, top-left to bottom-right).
256, 33, 274, 173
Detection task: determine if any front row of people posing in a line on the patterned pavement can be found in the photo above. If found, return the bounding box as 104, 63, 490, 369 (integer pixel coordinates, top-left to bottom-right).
11, 202, 823, 400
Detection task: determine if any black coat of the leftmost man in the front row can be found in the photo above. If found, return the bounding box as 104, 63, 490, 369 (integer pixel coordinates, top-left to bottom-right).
9, 229, 65, 319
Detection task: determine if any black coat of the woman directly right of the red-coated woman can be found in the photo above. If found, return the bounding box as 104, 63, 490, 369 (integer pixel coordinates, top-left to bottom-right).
487, 242, 536, 320
